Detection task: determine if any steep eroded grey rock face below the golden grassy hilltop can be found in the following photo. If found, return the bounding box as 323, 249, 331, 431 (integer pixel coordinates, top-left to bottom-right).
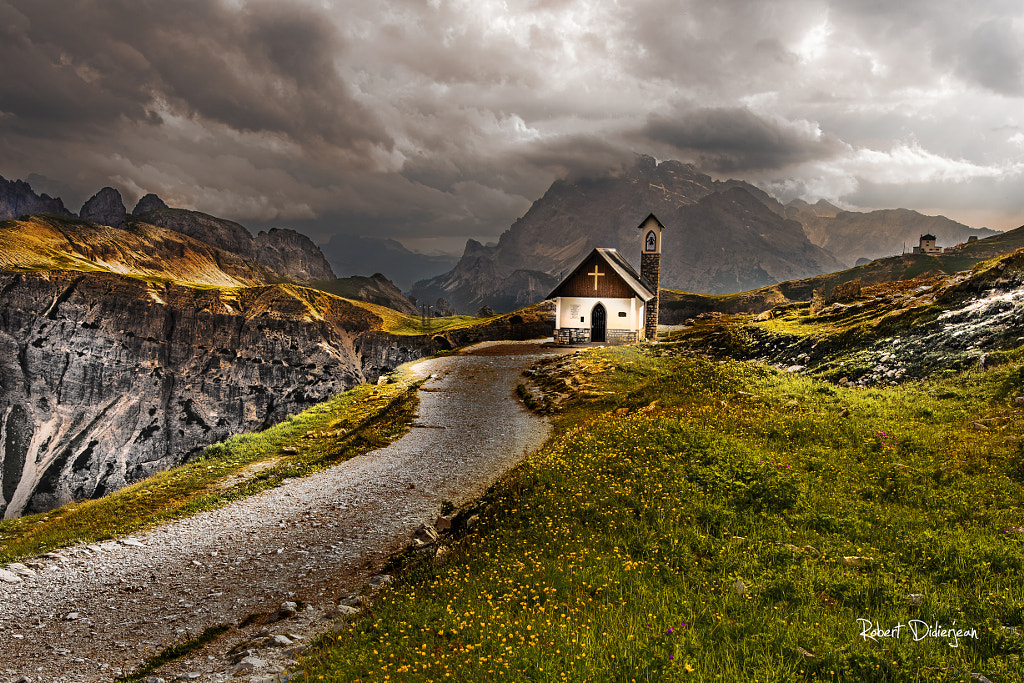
0, 271, 436, 517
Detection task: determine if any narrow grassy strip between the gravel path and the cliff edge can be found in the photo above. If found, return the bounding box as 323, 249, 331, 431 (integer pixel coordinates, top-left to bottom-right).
0, 371, 416, 565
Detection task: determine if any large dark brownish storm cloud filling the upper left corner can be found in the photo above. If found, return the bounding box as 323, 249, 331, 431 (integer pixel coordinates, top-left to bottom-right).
0, 0, 390, 152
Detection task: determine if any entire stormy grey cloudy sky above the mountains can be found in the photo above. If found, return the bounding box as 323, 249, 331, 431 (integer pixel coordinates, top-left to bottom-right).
0, 0, 1024, 251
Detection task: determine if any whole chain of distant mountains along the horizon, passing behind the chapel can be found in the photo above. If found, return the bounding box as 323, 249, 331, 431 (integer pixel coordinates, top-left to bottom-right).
0, 166, 997, 312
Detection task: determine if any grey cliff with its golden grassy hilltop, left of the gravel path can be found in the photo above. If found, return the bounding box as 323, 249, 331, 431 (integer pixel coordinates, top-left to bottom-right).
0, 215, 552, 517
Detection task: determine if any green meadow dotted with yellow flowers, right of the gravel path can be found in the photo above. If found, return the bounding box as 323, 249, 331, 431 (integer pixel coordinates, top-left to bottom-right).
303, 348, 1024, 682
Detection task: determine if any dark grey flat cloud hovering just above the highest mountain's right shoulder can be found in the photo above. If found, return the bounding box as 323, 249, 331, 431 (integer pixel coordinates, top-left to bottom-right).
641, 108, 843, 173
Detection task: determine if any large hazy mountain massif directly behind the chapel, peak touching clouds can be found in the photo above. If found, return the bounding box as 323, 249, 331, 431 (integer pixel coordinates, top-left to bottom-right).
413, 157, 842, 310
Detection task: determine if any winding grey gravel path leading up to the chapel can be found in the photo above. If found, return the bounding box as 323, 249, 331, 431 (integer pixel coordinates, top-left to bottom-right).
0, 343, 559, 683
